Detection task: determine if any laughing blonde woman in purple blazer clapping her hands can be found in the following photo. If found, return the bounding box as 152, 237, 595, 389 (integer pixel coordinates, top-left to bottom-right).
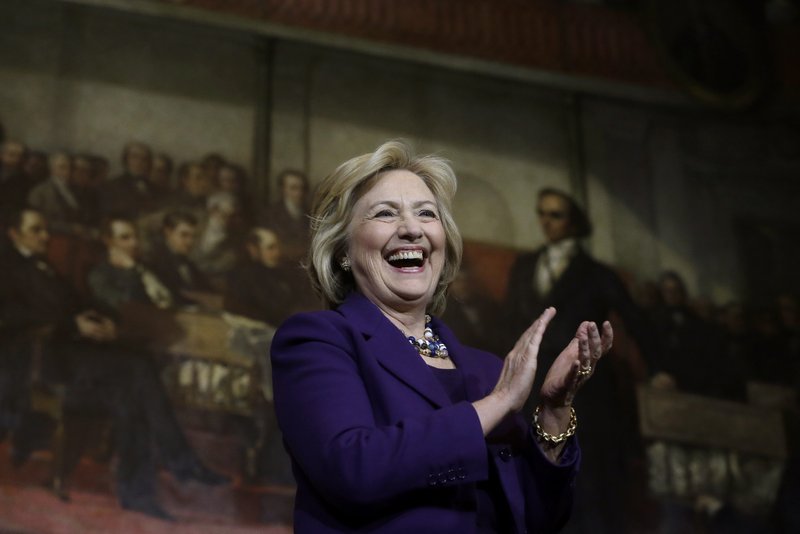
272, 141, 612, 534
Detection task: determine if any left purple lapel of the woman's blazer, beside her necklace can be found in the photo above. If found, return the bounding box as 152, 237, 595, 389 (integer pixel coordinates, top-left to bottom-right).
339, 293, 452, 408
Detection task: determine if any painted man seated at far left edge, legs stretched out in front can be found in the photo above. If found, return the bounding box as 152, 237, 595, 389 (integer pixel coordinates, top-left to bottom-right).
0, 208, 227, 518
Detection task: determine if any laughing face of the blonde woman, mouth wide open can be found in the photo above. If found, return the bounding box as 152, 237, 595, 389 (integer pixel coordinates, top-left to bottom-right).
347, 170, 445, 311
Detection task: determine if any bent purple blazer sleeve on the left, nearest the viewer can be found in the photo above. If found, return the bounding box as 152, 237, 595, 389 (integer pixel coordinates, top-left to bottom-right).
271, 312, 488, 507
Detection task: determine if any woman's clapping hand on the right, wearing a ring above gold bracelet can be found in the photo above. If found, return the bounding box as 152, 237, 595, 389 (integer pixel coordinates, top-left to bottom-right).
540, 321, 614, 408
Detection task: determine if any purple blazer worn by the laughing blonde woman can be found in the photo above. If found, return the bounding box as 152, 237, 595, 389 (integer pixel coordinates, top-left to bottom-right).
272, 293, 580, 534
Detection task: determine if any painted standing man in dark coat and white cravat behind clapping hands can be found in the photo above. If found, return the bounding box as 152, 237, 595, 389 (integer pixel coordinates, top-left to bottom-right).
505, 189, 652, 533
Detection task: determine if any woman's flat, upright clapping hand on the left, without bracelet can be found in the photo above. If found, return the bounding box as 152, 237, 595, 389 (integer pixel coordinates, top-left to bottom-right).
473, 308, 556, 435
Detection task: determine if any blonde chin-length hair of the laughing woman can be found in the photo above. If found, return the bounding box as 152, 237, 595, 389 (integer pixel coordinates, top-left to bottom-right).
306, 139, 462, 314
